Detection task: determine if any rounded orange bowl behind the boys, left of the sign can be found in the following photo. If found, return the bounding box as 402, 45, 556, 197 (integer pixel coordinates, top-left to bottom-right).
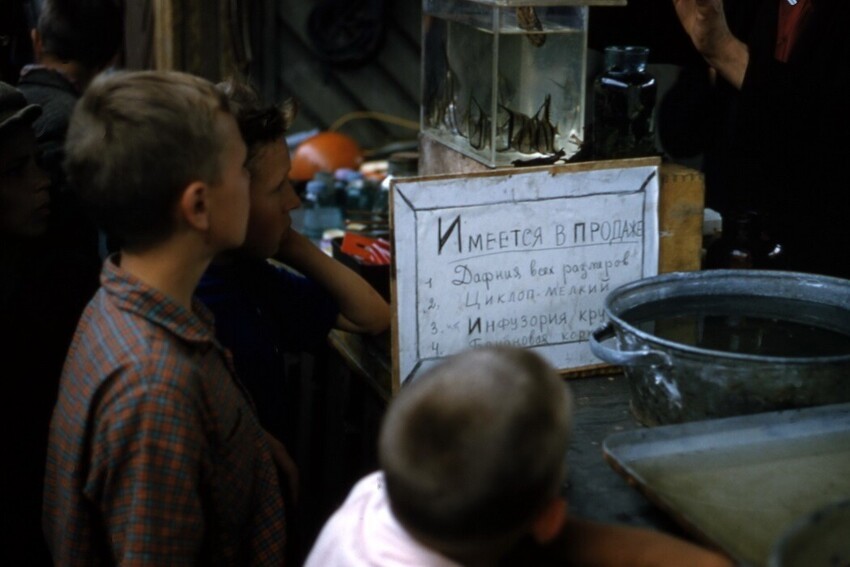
289, 132, 363, 181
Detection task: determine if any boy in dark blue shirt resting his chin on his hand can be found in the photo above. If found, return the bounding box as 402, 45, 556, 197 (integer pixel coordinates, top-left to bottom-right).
197, 79, 390, 563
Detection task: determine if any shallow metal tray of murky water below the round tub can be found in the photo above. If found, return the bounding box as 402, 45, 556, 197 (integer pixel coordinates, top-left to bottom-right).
603, 404, 850, 566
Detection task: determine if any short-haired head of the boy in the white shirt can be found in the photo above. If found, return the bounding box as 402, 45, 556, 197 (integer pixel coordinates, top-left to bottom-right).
379, 347, 571, 558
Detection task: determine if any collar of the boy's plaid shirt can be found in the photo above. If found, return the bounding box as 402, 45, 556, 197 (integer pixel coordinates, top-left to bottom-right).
100, 254, 216, 344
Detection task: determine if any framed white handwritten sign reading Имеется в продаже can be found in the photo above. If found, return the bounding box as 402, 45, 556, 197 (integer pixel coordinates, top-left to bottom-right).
391, 162, 659, 385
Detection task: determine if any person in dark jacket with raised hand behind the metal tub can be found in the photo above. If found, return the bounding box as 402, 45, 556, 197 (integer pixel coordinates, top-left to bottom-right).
673, 0, 850, 278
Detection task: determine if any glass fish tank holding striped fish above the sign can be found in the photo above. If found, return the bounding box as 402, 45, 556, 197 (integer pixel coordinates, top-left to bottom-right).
421, 0, 626, 167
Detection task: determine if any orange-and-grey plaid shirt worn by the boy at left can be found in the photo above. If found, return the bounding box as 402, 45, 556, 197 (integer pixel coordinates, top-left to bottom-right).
44, 258, 285, 566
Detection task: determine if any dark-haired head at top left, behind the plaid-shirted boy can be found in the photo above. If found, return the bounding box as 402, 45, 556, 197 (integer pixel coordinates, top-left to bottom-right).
33, 0, 124, 71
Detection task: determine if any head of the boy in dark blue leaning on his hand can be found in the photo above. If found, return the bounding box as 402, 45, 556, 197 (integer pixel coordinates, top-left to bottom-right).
218, 79, 301, 258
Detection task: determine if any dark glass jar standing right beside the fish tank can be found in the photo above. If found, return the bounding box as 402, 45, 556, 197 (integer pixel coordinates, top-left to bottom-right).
591, 46, 658, 159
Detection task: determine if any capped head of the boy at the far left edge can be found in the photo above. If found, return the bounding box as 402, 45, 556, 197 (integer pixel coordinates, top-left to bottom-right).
0, 82, 50, 238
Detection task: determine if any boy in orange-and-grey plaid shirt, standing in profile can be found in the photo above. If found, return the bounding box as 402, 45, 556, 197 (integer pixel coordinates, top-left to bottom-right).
43, 71, 284, 565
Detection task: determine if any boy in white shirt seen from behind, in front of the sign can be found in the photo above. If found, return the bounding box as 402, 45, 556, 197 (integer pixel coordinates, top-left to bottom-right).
306, 347, 731, 567
